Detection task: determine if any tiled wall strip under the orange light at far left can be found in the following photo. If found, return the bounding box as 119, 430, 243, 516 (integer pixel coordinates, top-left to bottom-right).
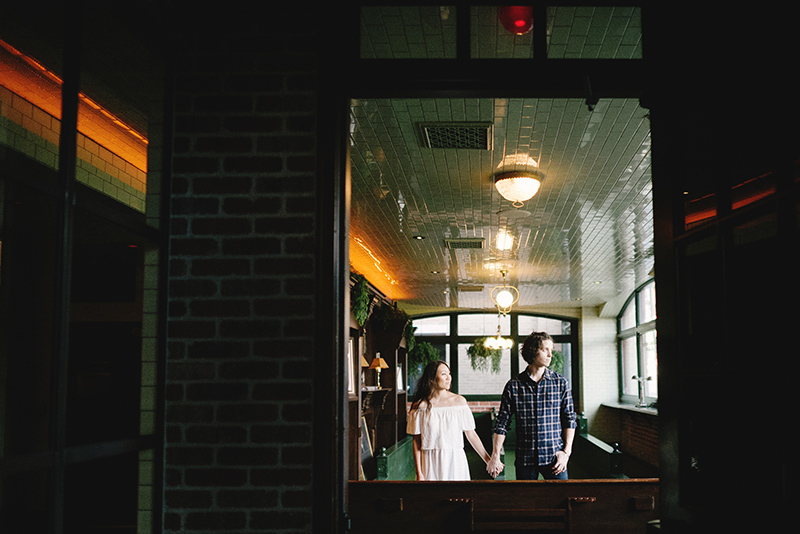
0, 86, 147, 212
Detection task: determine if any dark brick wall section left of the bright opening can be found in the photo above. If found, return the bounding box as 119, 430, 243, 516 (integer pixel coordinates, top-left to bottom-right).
164, 17, 316, 533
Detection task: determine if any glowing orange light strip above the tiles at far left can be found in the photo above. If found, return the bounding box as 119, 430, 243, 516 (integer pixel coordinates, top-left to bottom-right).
0, 40, 147, 172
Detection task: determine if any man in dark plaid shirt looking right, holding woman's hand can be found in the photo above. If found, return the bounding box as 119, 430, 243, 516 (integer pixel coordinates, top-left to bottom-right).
486, 332, 578, 480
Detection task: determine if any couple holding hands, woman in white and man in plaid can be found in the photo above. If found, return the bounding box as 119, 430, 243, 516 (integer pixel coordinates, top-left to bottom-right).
407, 332, 578, 480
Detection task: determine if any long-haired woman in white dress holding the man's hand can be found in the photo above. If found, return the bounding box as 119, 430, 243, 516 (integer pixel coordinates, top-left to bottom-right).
406, 361, 491, 480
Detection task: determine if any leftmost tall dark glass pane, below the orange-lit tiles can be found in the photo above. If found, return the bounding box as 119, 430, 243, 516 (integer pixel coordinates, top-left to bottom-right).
0, 181, 58, 458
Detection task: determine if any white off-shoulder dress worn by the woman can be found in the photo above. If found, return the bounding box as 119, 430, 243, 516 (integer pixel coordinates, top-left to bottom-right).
406, 404, 475, 480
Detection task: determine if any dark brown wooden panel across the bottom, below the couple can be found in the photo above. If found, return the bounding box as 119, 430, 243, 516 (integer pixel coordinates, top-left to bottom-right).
348, 479, 658, 534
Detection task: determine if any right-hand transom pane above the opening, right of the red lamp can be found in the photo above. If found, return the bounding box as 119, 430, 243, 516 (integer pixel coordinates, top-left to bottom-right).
547, 6, 642, 59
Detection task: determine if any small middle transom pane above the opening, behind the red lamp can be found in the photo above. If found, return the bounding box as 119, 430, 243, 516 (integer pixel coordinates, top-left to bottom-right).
470, 6, 533, 59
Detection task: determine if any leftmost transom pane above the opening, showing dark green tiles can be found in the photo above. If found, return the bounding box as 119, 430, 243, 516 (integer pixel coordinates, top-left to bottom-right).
361, 6, 456, 59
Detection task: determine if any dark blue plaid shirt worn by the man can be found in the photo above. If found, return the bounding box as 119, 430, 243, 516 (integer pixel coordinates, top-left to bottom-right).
494, 369, 578, 465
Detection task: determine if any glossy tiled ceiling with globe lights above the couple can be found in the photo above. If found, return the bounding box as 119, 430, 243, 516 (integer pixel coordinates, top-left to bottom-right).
351, 8, 653, 314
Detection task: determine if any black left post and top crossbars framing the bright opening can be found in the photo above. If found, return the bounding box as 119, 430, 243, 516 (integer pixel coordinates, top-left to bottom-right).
314, 1, 647, 533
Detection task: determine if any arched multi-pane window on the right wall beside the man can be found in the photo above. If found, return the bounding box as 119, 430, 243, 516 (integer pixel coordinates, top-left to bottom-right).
617, 280, 658, 406
